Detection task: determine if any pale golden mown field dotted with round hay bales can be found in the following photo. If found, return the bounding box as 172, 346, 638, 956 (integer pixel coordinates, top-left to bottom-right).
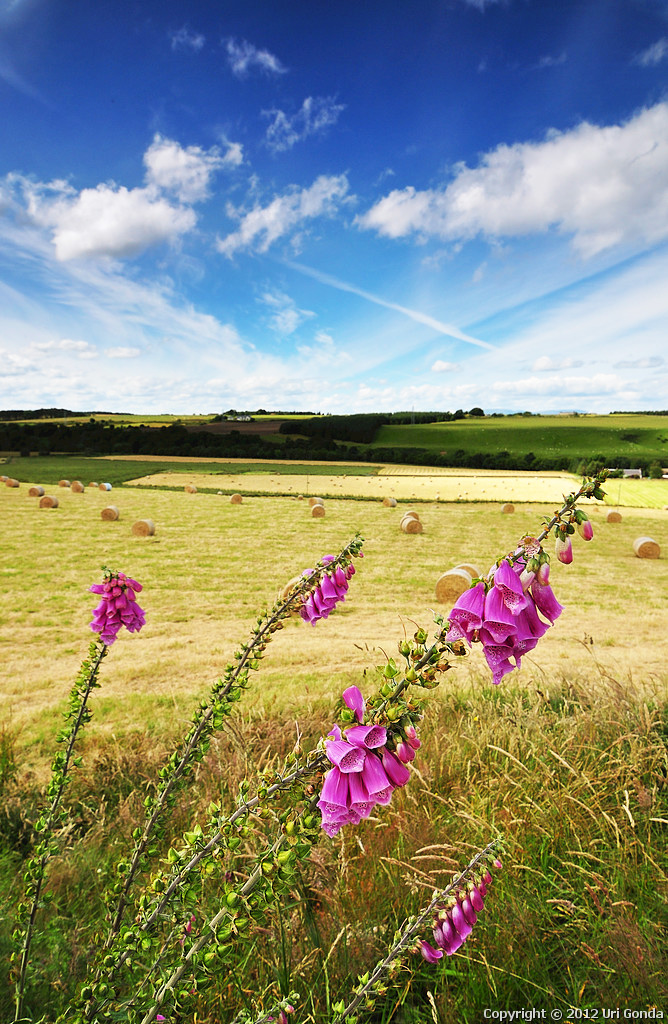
0, 477, 668, 764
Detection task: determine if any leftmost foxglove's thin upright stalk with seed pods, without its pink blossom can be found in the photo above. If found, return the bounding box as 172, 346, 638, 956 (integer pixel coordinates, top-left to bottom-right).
14, 640, 109, 1022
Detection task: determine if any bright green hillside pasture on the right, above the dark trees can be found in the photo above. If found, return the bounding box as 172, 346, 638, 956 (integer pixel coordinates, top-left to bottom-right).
372, 414, 668, 466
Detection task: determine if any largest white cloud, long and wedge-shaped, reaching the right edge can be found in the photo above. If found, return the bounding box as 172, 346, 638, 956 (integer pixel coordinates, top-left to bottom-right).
358, 102, 668, 257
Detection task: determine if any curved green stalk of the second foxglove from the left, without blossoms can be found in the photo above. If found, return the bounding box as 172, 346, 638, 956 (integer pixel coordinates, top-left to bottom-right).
105, 535, 363, 949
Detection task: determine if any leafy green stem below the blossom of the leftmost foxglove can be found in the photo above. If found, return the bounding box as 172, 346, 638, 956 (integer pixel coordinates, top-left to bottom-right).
14, 640, 109, 1022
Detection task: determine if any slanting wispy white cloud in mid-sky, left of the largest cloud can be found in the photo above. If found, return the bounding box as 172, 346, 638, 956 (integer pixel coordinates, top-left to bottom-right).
217, 174, 348, 256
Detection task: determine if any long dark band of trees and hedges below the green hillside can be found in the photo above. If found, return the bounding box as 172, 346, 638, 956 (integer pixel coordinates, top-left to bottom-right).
0, 417, 658, 475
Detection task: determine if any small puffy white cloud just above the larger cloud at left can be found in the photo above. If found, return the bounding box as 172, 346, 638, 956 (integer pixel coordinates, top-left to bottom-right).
143, 134, 233, 203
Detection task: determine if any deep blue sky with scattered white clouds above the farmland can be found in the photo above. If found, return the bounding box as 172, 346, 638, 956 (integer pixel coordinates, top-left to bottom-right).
0, 0, 668, 414
